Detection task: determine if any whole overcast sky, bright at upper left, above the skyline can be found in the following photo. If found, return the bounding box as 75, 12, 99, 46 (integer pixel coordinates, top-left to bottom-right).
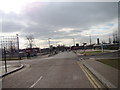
0, 0, 118, 48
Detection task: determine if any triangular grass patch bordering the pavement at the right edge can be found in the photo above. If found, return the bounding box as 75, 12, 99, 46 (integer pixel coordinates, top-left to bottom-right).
96, 59, 120, 70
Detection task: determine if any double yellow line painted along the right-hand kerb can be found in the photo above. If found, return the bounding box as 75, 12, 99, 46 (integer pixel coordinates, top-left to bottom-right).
77, 61, 102, 90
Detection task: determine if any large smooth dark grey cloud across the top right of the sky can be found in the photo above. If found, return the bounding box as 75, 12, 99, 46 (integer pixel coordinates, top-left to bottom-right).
23, 2, 117, 27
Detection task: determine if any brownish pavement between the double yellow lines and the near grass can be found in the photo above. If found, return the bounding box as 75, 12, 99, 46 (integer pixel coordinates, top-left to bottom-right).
80, 60, 118, 88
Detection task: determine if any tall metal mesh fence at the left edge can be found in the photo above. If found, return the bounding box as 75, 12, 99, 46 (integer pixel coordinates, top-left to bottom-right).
0, 35, 19, 59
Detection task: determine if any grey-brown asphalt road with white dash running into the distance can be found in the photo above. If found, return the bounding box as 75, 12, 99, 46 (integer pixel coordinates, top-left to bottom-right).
2, 52, 93, 88
